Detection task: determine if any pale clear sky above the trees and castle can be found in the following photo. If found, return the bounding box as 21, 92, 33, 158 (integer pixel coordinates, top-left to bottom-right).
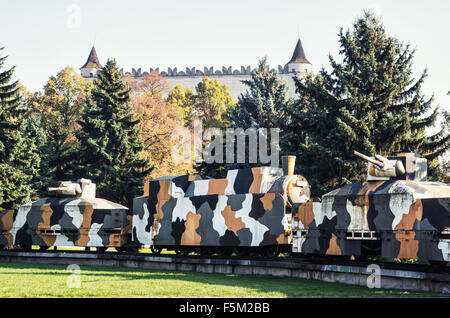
0, 0, 450, 120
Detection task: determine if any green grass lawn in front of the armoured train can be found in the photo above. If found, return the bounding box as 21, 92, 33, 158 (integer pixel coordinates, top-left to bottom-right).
0, 263, 440, 297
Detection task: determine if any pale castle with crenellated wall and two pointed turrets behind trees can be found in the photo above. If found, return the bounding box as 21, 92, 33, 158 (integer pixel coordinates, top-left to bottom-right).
80, 38, 312, 98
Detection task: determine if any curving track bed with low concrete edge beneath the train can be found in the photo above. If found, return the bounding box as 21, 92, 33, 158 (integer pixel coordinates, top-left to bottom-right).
0, 250, 450, 293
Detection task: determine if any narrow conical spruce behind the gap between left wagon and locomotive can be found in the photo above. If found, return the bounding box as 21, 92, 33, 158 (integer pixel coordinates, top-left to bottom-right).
74, 59, 151, 206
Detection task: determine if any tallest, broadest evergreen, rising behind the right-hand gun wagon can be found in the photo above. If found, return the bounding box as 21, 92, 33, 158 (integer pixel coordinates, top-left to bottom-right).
284, 12, 449, 195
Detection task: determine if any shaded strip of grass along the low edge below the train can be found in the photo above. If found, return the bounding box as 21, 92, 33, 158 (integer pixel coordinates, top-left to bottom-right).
0, 263, 443, 297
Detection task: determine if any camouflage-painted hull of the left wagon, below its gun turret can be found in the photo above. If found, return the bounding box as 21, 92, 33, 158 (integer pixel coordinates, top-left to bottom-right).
0, 181, 132, 247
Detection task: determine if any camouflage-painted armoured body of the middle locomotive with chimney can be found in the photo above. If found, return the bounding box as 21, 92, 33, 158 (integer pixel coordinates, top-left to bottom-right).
133, 167, 309, 247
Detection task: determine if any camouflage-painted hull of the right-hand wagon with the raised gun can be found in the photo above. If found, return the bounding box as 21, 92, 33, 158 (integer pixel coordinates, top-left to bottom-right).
292, 154, 450, 262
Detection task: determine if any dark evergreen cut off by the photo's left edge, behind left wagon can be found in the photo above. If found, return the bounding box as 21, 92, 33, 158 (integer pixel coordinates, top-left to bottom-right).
0, 48, 40, 209
